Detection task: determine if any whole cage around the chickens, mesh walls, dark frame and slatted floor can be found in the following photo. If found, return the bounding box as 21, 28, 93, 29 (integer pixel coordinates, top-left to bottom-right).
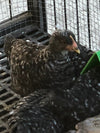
0, 0, 100, 133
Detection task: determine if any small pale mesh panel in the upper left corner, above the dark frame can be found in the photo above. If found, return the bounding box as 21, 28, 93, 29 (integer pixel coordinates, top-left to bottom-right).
0, 0, 28, 22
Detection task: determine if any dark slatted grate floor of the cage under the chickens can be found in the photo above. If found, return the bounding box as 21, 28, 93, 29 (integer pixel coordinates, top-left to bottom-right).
0, 25, 49, 133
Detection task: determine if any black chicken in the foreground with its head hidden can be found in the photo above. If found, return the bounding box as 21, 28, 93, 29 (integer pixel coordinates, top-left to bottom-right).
8, 68, 100, 133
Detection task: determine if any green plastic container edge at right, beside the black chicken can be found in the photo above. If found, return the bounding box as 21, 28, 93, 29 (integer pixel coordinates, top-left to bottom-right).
80, 51, 100, 75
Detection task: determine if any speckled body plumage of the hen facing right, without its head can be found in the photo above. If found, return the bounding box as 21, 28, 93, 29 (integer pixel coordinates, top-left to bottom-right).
5, 33, 92, 96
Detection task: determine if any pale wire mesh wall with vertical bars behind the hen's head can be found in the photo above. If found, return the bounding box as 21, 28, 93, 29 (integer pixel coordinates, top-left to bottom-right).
46, 0, 100, 50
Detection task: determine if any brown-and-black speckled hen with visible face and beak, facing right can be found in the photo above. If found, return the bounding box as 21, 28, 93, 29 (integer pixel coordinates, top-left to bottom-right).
4, 30, 92, 96
